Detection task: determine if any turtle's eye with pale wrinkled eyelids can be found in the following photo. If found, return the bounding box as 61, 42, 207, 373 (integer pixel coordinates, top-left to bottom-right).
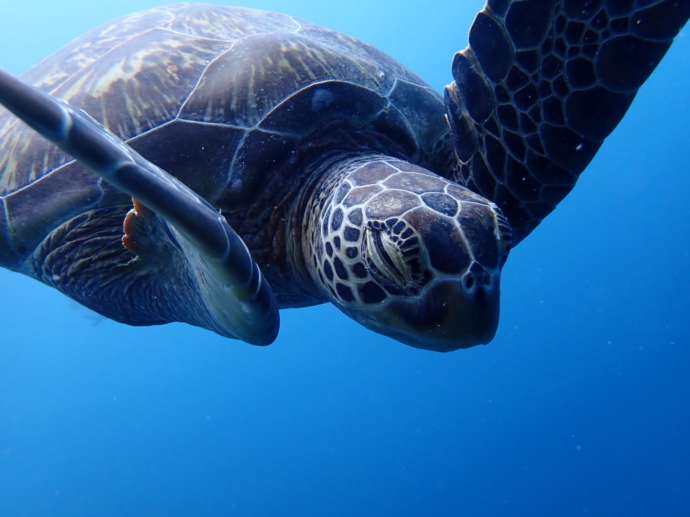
362, 225, 419, 294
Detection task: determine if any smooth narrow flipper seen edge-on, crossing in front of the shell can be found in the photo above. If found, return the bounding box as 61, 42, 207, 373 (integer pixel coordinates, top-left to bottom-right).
0, 66, 279, 345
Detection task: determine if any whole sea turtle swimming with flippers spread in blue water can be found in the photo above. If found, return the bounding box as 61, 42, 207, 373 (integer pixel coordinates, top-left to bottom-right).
0, 0, 690, 351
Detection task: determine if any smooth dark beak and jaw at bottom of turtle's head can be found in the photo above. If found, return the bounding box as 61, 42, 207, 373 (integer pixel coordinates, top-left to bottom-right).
346, 273, 500, 352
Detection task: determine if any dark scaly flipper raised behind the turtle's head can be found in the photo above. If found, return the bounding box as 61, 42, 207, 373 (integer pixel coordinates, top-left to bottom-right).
446, 0, 690, 243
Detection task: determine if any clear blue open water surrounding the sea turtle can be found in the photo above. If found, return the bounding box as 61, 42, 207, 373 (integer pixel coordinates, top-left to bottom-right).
0, 0, 690, 517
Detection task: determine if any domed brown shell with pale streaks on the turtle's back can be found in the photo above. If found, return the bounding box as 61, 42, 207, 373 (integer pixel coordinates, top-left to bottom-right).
0, 5, 451, 262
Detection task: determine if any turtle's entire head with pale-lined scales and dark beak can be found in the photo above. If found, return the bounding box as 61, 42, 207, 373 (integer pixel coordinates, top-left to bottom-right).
308, 157, 510, 351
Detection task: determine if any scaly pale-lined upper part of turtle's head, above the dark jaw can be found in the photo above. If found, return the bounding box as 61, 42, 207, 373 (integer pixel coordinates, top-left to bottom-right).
298, 151, 510, 348
